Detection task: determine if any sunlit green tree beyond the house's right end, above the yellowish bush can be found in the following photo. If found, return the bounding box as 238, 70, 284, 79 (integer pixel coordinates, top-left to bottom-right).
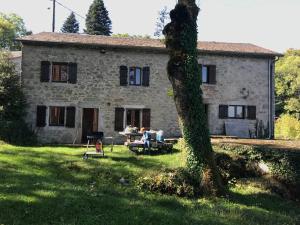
275, 49, 300, 119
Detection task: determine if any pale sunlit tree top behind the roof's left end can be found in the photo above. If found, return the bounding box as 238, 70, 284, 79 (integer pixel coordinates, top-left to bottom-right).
0, 13, 31, 50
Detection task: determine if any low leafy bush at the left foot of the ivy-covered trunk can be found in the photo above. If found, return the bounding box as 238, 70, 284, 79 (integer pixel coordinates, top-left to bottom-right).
137, 168, 201, 198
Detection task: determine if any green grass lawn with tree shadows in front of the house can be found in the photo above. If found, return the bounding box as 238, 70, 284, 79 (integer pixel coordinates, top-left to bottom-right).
0, 144, 300, 225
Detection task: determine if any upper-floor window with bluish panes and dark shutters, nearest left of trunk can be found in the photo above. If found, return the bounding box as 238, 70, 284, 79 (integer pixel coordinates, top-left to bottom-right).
120, 66, 150, 86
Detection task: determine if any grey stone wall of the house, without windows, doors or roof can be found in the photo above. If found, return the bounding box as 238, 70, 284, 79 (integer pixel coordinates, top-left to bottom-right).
22, 40, 273, 143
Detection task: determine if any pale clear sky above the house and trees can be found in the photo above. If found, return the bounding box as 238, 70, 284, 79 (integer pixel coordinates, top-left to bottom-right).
0, 0, 300, 53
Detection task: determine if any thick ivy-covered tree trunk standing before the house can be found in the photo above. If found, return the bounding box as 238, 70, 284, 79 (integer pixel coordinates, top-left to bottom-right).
164, 0, 225, 195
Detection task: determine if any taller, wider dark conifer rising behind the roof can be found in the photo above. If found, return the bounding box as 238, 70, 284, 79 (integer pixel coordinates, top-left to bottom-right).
85, 0, 112, 36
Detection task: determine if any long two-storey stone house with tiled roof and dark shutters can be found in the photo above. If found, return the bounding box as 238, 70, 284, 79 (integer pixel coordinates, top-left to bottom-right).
20, 32, 280, 143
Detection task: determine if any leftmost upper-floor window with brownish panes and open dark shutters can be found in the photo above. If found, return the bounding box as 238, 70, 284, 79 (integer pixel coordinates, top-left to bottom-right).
40, 61, 77, 84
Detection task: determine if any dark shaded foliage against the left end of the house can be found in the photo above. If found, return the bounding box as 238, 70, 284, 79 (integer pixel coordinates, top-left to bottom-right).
0, 52, 36, 145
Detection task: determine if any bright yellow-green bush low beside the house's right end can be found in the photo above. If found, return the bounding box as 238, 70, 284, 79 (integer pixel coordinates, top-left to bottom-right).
275, 114, 300, 139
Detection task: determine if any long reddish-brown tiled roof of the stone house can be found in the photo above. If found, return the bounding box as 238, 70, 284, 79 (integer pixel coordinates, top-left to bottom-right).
19, 32, 281, 56
